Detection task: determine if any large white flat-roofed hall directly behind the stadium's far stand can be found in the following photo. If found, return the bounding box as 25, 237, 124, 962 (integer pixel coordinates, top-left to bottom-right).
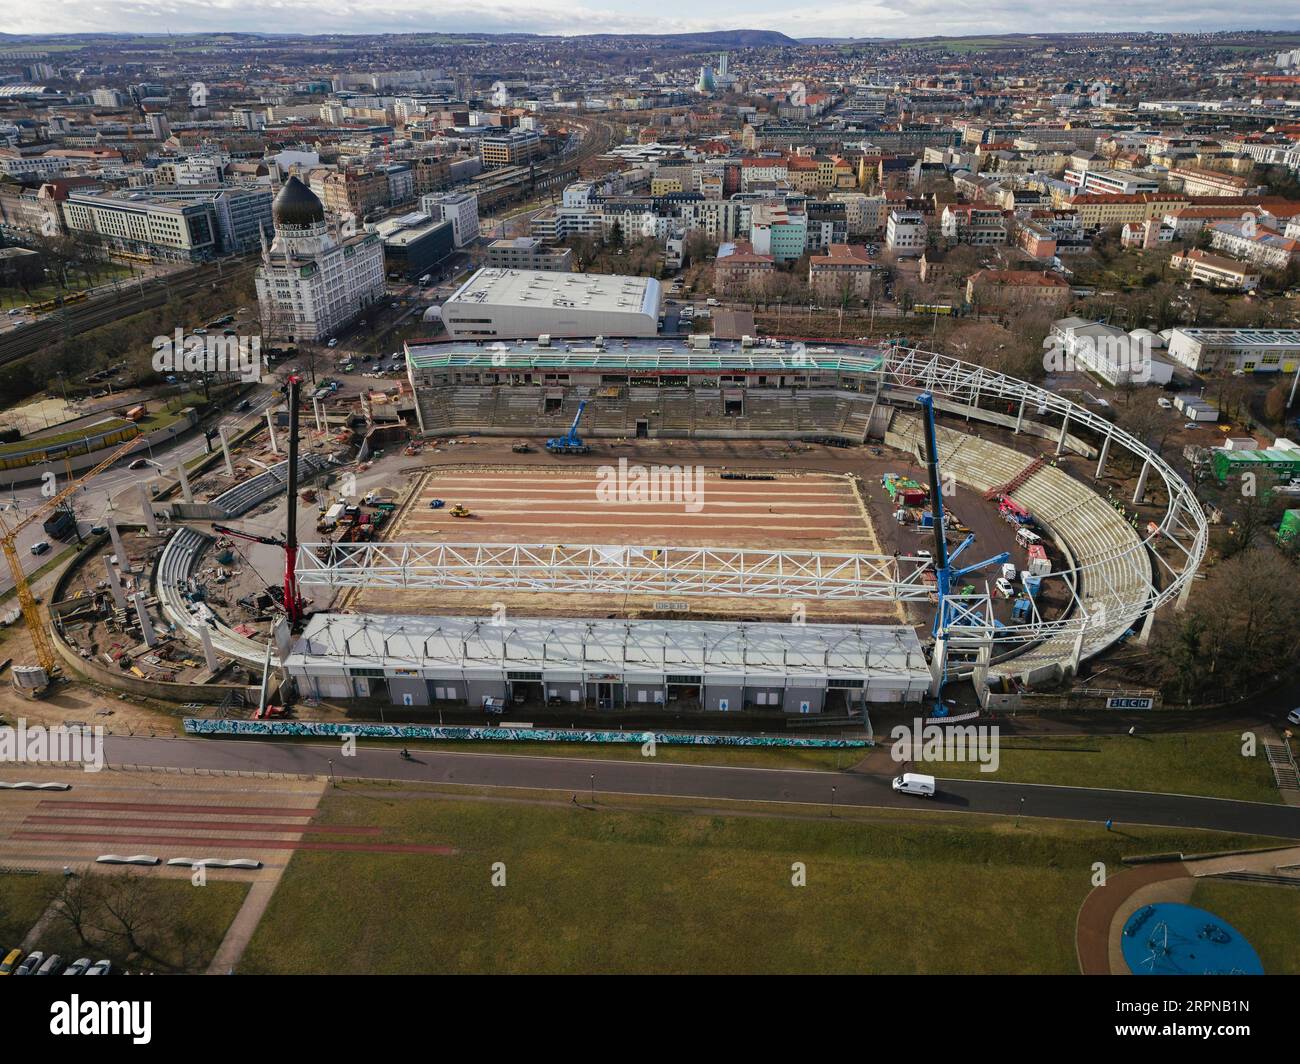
442, 269, 663, 341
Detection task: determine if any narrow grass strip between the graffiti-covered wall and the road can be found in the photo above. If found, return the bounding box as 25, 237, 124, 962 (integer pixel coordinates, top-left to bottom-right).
390, 740, 871, 771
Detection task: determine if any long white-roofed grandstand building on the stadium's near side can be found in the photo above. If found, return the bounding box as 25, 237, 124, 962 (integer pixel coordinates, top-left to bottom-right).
285, 614, 931, 714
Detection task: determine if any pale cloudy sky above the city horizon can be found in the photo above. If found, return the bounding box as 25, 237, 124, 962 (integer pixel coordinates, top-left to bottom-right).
10, 0, 1300, 36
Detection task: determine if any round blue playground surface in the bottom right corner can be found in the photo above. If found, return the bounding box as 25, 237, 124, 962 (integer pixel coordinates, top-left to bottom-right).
1121, 901, 1264, 976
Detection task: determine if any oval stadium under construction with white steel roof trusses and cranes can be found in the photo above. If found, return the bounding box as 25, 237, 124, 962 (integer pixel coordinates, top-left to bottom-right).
86, 337, 1206, 726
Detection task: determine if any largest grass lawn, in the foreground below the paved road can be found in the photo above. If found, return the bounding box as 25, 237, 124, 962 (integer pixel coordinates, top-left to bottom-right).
239, 786, 1261, 973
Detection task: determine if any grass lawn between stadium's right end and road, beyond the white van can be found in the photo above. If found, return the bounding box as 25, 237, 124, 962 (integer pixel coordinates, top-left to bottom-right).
927, 731, 1281, 803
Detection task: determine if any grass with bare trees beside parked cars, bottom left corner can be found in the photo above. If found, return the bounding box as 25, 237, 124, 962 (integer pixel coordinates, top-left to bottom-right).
0, 873, 248, 973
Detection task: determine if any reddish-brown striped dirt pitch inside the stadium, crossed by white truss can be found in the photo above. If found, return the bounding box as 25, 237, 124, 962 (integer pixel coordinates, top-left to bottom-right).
348, 462, 902, 623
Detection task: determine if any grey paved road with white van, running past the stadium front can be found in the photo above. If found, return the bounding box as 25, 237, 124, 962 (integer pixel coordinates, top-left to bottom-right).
98, 736, 1300, 839
